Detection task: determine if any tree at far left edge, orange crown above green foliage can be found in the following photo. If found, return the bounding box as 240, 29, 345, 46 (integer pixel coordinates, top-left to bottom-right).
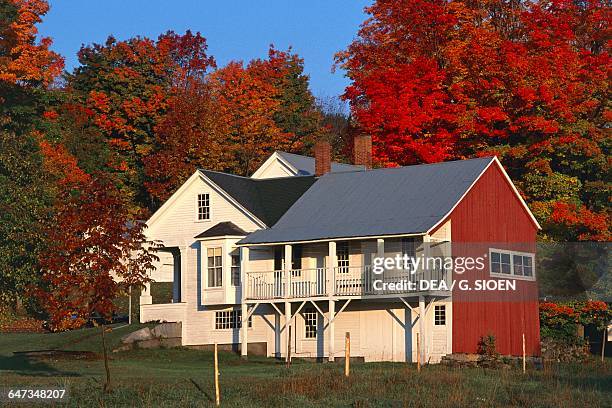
0, 0, 63, 309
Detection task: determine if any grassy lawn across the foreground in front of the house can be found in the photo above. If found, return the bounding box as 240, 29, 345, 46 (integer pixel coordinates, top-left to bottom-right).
0, 326, 612, 407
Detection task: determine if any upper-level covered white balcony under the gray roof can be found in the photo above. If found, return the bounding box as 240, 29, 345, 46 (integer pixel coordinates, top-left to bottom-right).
241, 236, 452, 302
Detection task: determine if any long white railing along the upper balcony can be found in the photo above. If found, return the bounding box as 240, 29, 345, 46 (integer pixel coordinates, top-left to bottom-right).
245, 266, 451, 300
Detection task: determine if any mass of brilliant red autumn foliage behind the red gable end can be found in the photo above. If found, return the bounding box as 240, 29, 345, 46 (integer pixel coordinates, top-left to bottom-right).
338, 0, 610, 239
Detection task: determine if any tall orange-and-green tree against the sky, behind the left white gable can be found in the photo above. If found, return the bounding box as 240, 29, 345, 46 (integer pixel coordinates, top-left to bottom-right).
67, 31, 214, 207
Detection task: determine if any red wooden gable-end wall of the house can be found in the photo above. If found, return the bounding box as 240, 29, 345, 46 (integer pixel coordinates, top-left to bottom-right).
442, 163, 540, 355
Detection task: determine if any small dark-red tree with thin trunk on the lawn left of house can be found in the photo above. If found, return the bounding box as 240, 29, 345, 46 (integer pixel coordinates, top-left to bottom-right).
31, 140, 157, 391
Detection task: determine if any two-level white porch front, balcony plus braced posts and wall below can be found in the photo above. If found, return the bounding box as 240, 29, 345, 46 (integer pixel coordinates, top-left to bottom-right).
238, 235, 452, 362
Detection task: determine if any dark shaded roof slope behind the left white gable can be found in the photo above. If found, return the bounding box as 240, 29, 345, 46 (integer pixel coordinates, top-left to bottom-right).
199, 169, 315, 226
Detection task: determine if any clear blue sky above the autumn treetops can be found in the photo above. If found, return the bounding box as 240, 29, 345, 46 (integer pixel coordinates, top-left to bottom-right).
40, 0, 371, 96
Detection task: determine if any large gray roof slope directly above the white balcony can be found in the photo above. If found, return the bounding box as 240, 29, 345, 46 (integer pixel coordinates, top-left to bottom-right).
239, 157, 493, 244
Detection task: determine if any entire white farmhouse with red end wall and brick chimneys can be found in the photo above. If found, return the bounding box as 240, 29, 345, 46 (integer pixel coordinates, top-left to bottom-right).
140, 137, 539, 362
